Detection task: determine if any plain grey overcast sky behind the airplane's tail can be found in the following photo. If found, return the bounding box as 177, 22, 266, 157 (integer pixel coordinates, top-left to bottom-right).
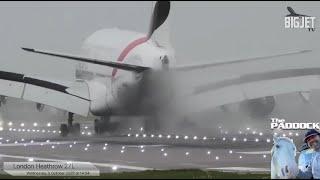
0, 1, 320, 79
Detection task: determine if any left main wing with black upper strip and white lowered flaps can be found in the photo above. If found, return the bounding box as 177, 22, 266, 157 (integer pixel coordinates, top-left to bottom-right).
0, 71, 90, 116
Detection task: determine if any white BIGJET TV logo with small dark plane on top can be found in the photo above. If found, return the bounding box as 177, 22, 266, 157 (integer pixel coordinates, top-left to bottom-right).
284, 7, 316, 31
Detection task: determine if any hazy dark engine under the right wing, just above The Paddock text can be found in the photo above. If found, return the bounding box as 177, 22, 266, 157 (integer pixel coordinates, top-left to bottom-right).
240, 96, 276, 118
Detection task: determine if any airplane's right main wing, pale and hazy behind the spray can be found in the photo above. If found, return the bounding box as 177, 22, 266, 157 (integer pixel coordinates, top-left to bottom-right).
175, 68, 320, 113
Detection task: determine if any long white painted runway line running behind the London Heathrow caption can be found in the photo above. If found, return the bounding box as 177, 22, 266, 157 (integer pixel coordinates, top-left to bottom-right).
0, 154, 153, 171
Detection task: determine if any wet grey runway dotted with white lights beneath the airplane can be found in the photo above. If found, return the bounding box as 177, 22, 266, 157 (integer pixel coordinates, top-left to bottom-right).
0, 119, 304, 172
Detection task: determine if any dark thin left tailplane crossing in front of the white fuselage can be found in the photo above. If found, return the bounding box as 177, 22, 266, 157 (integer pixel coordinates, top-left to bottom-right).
22, 48, 149, 73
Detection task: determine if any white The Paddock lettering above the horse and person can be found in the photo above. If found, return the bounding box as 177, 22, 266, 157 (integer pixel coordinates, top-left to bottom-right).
271, 118, 320, 130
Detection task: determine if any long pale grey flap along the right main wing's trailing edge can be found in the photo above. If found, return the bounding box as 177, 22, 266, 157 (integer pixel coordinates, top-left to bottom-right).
181, 75, 320, 114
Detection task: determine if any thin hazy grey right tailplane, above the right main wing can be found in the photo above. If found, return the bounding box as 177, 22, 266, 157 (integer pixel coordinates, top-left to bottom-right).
173, 50, 311, 71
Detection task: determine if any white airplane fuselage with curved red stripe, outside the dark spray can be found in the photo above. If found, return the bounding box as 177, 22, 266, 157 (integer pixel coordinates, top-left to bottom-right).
76, 28, 174, 115
